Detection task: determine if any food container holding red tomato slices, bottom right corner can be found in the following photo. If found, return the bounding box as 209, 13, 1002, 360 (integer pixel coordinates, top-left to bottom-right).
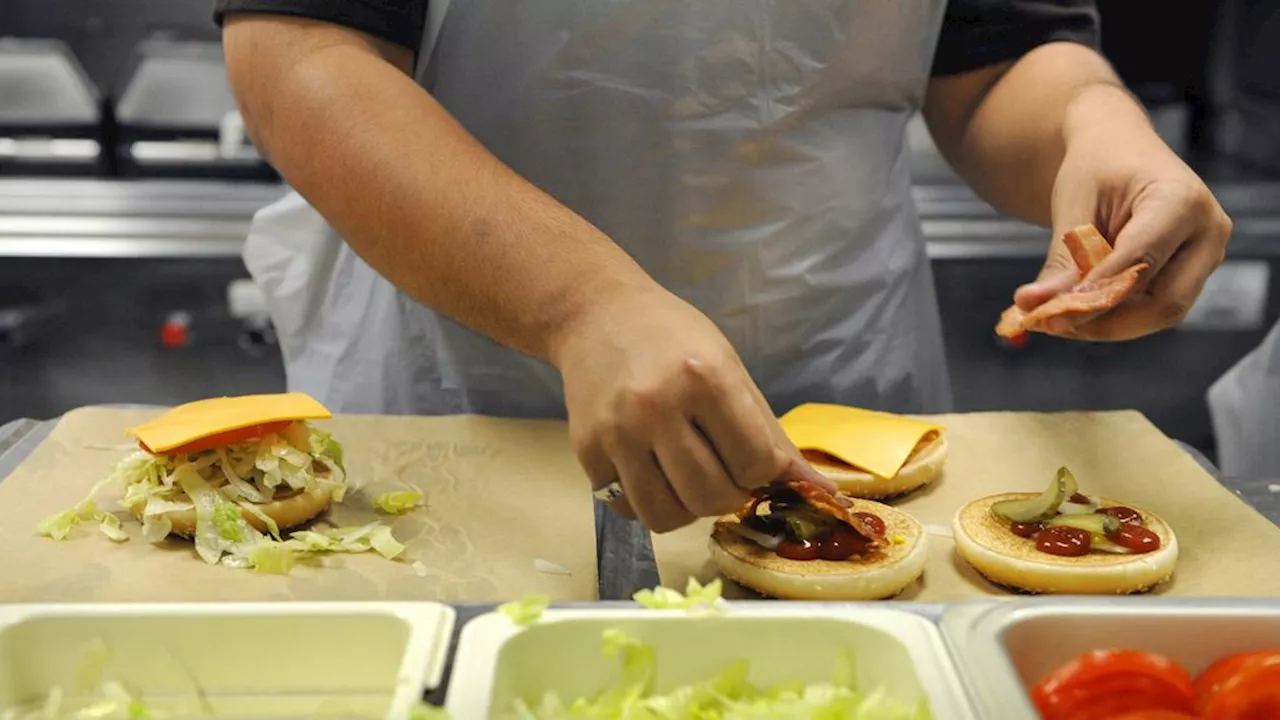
942, 597, 1280, 720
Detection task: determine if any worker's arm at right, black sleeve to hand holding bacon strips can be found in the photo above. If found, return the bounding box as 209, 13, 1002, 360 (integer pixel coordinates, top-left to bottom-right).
924, 0, 1231, 340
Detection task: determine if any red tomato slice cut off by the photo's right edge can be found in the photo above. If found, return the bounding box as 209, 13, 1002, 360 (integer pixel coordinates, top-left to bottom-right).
1197, 651, 1280, 720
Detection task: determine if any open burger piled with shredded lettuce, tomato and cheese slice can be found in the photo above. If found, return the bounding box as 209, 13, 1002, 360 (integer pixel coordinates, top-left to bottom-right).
37, 393, 403, 571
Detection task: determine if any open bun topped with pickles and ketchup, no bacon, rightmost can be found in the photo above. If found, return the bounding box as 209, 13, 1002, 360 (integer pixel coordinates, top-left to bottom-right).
951, 468, 1178, 594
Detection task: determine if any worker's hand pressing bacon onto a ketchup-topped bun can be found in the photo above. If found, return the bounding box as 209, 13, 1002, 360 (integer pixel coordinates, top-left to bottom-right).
552, 287, 835, 533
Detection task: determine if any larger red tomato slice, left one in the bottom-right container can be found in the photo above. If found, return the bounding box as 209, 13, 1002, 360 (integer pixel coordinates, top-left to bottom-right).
1032, 650, 1196, 720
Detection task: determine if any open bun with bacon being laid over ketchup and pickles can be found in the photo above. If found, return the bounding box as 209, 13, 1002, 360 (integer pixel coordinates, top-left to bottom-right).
710, 480, 928, 601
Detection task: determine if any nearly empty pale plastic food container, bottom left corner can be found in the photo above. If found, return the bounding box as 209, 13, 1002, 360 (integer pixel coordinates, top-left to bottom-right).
0, 602, 454, 719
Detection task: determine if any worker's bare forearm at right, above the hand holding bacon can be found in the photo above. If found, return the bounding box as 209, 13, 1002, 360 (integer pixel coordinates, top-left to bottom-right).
925, 42, 1151, 225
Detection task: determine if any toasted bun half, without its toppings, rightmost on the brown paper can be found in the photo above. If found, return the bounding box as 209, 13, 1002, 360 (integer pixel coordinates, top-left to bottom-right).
951, 492, 1178, 594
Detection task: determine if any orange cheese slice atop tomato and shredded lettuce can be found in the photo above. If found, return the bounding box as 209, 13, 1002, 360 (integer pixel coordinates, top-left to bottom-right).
124, 392, 333, 452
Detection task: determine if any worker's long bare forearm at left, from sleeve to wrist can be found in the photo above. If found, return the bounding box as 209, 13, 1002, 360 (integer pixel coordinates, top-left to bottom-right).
224, 19, 655, 359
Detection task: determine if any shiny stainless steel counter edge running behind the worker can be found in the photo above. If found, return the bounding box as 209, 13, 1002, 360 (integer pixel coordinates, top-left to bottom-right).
0, 179, 1280, 260
